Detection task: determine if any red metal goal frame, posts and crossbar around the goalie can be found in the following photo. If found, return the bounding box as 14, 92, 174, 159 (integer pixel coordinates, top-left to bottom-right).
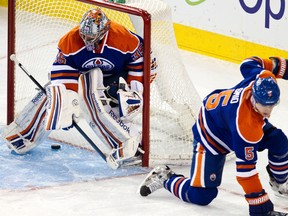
7, 0, 151, 167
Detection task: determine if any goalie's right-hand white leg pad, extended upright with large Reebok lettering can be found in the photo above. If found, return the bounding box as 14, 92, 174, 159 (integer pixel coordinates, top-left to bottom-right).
79, 68, 141, 165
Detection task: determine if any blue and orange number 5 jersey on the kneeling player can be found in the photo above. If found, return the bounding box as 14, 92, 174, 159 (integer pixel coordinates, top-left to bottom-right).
192, 57, 288, 193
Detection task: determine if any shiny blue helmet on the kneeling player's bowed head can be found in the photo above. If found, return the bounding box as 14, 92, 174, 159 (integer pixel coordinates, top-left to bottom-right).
252, 77, 280, 106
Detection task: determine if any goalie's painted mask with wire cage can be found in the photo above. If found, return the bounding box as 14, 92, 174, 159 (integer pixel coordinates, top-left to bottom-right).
79, 7, 110, 51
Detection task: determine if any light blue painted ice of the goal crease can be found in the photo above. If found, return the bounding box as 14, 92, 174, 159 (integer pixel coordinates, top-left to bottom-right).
0, 125, 149, 190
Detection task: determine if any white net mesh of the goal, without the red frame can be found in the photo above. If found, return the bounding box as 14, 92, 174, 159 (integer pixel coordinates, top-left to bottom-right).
10, 0, 200, 164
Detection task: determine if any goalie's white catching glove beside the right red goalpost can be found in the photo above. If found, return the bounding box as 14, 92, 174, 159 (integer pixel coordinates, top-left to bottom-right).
117, 77, 143, 121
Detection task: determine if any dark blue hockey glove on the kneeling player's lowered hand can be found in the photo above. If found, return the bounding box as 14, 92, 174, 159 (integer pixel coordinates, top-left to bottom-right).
245, 189, 274, 216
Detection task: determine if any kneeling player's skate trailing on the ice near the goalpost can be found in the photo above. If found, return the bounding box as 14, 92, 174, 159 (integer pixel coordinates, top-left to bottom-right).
139, 165, 174, 196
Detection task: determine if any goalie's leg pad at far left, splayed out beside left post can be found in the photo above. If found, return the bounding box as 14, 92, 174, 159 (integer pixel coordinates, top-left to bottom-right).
2, 92, 49, 154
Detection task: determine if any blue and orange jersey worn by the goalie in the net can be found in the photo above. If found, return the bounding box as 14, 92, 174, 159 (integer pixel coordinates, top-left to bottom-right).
50, 21, 143, 95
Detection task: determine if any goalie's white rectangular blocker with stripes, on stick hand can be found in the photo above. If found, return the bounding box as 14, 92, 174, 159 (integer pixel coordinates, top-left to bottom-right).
45, 84, 80, 130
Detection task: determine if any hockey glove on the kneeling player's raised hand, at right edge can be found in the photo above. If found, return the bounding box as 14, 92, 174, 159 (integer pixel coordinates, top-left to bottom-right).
269, 57, 288, 80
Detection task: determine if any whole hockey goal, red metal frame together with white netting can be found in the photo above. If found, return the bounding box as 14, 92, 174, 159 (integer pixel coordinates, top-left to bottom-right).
7, 0, 201, 166
